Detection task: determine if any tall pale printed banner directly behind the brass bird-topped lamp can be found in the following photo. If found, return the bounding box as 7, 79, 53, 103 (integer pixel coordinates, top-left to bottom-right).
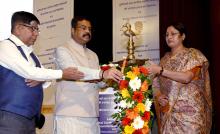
113, 0, 159, 63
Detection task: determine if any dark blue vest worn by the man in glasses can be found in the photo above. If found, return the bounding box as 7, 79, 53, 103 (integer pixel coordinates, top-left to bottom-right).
0, 39, 43, 119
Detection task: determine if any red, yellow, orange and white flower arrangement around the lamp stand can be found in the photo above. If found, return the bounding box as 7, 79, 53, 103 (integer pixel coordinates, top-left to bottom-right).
101, 61, 153, 134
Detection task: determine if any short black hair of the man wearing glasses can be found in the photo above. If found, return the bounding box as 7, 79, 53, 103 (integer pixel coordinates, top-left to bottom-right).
11, 11, 40, 32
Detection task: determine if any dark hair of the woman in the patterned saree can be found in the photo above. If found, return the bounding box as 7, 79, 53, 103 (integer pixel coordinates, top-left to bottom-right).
168, 22, 188, 46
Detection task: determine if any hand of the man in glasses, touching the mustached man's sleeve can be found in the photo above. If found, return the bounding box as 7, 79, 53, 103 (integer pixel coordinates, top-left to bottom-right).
62, 67, 84, 80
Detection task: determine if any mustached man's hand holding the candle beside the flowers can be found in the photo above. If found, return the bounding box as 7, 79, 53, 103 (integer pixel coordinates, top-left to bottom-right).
103, 68, 123, 82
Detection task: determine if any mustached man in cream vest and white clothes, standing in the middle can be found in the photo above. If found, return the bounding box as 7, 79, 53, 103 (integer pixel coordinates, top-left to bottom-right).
54, 17, 119, 134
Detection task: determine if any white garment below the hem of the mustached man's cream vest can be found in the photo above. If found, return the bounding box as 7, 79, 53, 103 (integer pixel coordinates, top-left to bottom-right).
54, 116, 100, 134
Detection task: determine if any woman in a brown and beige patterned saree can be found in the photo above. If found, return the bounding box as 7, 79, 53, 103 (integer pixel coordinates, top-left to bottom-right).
149, 23, 212, 134
